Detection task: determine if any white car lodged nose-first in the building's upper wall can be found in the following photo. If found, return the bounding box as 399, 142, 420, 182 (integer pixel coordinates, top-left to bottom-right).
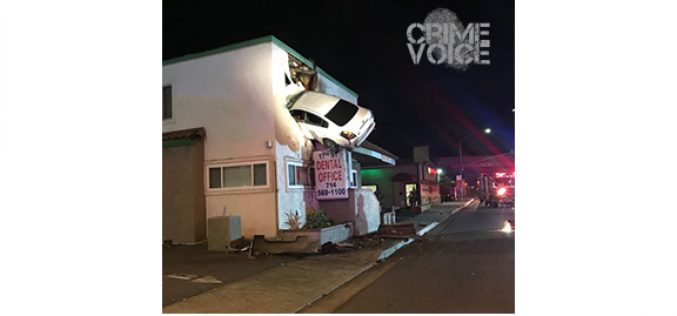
289, 91, 376, 152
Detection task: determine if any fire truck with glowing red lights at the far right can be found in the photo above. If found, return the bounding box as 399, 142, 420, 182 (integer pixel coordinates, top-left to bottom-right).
478, 172, 515, 207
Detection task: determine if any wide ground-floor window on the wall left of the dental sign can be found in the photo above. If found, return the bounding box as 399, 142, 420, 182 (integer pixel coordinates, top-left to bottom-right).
209, 162, 268, 189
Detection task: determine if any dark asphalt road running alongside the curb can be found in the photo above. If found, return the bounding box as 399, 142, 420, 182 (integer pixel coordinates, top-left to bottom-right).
334, 206, 515, 313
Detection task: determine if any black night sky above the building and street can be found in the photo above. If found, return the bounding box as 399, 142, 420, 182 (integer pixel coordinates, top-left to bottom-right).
163, 0, 515, 158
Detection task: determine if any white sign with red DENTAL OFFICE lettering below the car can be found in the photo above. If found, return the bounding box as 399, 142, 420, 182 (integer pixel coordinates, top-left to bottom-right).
313, 150, 349, 200
